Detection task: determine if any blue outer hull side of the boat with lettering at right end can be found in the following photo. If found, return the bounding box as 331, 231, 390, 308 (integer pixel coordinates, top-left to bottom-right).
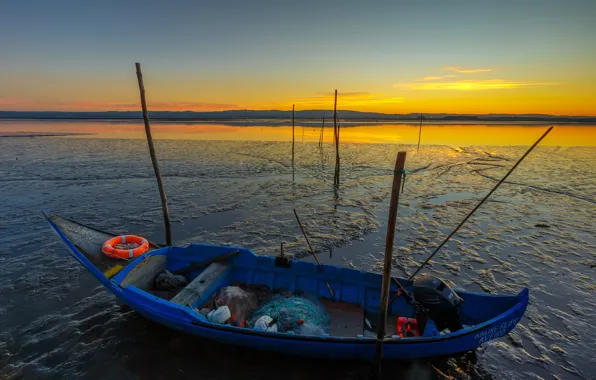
47, 218, 528, 360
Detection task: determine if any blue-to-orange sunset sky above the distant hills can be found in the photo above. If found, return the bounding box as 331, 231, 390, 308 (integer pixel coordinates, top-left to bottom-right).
0, 0, 596, 115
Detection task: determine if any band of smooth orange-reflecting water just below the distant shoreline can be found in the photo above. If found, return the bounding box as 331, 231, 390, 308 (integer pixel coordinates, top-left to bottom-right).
0, 120, 596, 146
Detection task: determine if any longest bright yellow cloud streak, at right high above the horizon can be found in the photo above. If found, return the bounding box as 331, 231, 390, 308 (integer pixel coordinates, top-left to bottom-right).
393, 79, 557, 91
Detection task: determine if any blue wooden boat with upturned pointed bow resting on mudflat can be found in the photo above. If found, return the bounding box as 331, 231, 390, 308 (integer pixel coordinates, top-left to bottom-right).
44, 214, 528, 360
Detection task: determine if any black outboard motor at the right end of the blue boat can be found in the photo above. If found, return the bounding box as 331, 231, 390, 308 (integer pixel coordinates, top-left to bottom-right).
414, 275, 463, 332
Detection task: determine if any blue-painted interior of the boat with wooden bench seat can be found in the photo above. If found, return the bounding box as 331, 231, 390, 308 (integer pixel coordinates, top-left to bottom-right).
113, 244, 428, 337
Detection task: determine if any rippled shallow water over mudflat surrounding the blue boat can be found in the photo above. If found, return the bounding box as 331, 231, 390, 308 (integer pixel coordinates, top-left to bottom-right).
0, 121, 596, 379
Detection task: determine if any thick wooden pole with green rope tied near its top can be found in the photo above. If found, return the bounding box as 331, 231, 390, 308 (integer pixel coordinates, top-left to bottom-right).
371, 152, 406, 379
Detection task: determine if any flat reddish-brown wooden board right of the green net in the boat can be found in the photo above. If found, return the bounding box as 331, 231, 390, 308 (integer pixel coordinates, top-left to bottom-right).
321, 299, 364, 337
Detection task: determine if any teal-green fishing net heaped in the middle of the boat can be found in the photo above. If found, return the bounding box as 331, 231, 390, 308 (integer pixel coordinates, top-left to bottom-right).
249, 294, 330, 335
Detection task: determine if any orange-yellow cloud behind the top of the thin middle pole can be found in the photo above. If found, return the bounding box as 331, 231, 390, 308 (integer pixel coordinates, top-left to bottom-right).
289, 91, 404, 109
